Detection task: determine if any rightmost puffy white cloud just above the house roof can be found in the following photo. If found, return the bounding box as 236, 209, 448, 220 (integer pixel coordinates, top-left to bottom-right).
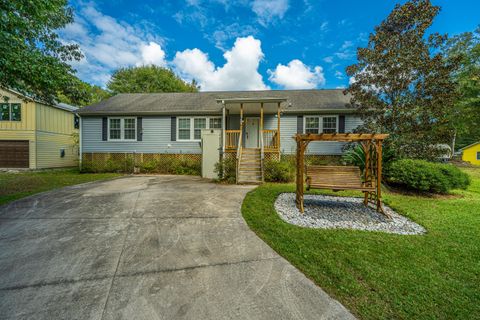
268, 59, 325, 89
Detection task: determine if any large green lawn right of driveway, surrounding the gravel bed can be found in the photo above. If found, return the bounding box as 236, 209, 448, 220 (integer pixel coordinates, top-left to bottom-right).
242, 169, 480, 319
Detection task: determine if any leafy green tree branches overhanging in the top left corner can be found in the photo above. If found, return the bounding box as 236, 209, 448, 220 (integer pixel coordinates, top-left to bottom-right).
0, 0, 82, 102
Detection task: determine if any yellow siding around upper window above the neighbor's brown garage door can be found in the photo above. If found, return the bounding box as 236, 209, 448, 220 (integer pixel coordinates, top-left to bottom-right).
0, 89, 35, 130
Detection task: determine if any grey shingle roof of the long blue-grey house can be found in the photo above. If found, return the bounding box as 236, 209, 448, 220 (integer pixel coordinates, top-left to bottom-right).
78, 89, 354, 115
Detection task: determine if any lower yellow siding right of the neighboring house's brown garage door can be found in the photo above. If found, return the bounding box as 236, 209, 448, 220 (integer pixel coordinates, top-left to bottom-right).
37, 131, 78, 169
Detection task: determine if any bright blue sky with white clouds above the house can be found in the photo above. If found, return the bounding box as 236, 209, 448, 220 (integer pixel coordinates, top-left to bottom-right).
60, 0, 480, 91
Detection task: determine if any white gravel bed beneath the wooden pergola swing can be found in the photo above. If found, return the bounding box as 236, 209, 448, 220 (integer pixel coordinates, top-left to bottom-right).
275, 193, 426, 235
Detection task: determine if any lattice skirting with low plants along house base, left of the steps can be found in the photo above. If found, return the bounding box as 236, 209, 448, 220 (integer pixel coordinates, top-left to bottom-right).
81, 152, 202, 175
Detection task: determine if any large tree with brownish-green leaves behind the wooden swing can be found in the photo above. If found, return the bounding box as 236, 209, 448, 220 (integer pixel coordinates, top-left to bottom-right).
346, 0, 458, 159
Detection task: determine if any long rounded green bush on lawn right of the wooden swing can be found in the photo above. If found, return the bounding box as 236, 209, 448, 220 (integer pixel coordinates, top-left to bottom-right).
385, 159, 470, 193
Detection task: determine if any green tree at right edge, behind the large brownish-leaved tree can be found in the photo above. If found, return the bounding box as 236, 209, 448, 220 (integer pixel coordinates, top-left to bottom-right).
443, 27, 480, 147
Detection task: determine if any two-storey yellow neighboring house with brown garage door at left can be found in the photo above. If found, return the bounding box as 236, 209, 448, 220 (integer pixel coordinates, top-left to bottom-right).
0, 88, 78, 169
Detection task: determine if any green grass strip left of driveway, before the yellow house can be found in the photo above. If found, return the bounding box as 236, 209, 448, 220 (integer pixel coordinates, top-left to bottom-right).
0, 169, 119, 205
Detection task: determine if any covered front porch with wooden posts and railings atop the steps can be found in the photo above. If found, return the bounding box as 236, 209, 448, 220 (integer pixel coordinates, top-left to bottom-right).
217, 98, 286, 155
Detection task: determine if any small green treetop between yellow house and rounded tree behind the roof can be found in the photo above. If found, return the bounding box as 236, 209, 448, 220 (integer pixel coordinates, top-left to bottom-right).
58, 78, 112, 106
